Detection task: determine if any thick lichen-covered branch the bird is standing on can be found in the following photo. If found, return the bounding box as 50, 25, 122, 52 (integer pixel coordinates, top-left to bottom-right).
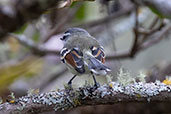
0, 81, 171, 114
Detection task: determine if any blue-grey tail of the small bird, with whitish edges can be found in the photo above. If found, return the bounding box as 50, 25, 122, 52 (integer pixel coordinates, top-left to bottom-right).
88, 57, 111, 75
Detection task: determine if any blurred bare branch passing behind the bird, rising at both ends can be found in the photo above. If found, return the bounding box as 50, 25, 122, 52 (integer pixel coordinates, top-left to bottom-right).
11, 22, 171, 60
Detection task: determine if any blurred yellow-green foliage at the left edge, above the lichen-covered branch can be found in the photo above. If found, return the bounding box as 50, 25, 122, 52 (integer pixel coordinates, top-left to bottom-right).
0, 56, 43, 91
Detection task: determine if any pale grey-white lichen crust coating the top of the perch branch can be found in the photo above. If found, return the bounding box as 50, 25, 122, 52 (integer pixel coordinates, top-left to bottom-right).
13, 81, 171, 110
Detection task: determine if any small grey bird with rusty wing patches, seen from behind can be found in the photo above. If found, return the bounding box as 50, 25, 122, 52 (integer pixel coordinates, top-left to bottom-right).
60, 28, 110, 87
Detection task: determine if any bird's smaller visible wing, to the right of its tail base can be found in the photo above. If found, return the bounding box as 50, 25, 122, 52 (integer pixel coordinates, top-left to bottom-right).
90, 46, 105, 64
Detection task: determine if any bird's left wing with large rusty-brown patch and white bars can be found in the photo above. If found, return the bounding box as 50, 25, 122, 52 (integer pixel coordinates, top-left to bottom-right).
61, 48, 85, 74
